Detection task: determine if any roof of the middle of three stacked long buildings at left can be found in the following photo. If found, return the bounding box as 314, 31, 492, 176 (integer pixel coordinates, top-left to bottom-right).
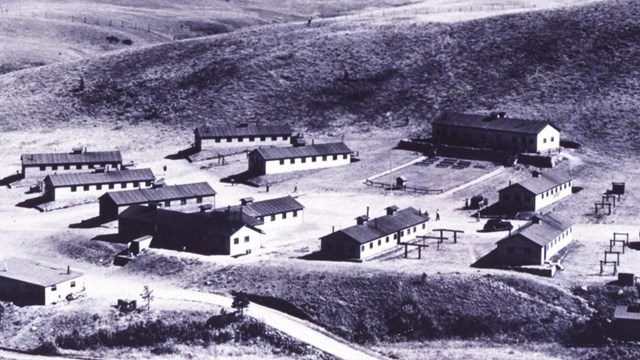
45, 169, 156, 187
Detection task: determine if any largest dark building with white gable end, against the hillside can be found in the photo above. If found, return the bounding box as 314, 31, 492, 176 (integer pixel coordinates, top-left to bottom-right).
432, 112, 560, 152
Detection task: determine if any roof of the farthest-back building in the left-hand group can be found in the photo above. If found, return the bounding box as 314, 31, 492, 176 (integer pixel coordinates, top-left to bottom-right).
20, 151, 122, 166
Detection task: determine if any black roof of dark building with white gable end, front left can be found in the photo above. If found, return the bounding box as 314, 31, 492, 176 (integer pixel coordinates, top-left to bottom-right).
118, 205, 262, 236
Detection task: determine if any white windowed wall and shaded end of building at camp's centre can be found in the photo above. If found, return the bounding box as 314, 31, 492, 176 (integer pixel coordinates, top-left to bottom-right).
249, 154, 351, 174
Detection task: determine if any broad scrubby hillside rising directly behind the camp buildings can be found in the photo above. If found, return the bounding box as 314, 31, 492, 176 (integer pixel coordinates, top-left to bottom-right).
0, 1, 640, 154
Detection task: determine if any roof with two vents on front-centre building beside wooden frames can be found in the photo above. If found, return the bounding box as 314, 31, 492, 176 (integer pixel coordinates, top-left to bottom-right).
321, 207, 428, 244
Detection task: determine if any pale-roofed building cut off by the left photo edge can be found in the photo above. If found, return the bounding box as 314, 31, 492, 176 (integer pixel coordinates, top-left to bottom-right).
0, 258, 84, 305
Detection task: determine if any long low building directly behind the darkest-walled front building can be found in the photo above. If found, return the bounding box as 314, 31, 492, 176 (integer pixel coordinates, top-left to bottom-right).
100, 182, 216, 220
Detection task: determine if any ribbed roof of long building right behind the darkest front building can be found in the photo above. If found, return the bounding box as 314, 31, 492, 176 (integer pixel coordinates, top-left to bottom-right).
101, 182, 216, 206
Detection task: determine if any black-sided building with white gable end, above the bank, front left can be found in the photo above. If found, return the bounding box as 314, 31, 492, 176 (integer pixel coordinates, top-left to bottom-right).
118, 205, 263, 256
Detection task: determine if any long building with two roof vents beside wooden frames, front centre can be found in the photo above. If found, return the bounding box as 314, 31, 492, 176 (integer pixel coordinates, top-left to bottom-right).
320, 206, 429, 260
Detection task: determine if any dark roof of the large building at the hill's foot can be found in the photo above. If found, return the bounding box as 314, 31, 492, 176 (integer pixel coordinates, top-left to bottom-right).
433, 112, 560, 135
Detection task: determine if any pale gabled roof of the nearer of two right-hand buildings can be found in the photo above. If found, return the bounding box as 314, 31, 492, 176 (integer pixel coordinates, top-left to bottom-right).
498, 213, 573, 246
